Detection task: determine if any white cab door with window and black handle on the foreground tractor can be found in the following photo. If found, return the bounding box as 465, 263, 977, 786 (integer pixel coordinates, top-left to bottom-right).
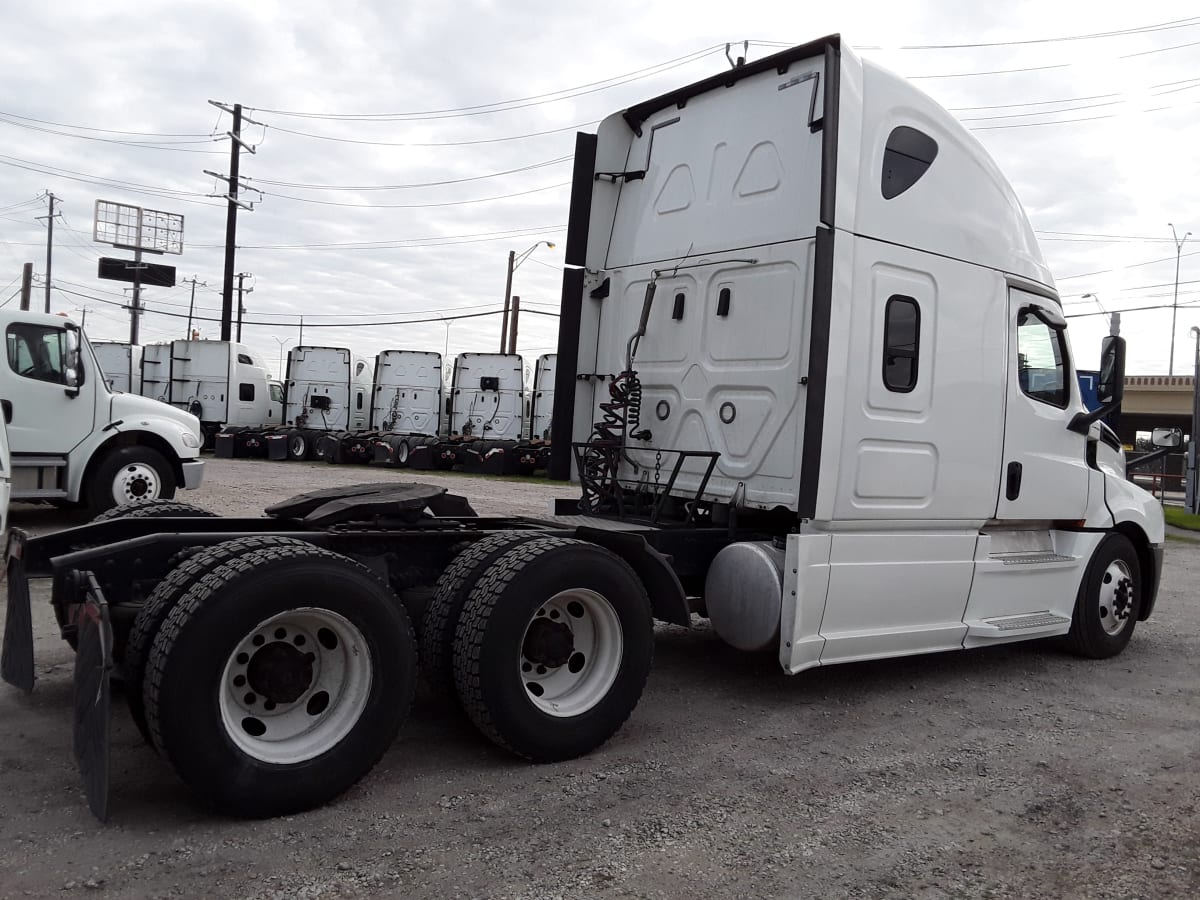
996, 288, 1088, 521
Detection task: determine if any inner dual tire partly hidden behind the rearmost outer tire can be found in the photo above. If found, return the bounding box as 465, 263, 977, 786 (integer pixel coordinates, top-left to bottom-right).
121, 540, 312, 749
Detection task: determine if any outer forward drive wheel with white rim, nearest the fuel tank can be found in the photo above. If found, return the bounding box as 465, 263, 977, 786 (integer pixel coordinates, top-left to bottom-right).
454, 538, 654, 762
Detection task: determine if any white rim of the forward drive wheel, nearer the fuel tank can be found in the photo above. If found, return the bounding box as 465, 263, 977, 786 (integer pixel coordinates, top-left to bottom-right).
517, 588, 625, 718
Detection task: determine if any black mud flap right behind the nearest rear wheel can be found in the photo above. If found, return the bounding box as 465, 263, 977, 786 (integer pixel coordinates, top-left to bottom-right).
74, 572, 113, 822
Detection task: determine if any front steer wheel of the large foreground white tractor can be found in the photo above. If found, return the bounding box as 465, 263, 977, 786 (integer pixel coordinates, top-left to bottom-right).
1067, 534, 1142, 659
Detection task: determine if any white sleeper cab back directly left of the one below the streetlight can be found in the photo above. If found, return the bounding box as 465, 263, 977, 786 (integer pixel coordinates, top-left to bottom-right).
370, 350, 443, 436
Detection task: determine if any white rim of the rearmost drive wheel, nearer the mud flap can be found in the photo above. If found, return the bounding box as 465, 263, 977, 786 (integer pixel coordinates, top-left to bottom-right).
220, 607, 372, 766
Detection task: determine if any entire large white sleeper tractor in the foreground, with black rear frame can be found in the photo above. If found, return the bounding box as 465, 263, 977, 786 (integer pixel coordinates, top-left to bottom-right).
4, 36, 1164, 816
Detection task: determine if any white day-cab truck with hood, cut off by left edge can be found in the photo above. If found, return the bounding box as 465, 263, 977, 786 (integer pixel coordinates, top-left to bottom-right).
0, 310, 204, 512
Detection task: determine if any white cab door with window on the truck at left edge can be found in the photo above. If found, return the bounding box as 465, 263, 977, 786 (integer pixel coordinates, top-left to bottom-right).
2, 322, 100, 454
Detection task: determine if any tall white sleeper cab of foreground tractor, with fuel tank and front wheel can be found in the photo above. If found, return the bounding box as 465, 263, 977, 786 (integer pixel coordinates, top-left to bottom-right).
554, 38, 1164, 672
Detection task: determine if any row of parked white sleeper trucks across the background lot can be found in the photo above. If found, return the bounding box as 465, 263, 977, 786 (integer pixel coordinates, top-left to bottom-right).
94, 341, 557, 474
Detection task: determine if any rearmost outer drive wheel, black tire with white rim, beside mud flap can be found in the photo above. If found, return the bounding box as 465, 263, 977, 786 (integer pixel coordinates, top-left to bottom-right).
144, 546, 416, 817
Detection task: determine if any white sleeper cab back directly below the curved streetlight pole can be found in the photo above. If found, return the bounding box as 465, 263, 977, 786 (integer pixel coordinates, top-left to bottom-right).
449, 353, 524, 440
